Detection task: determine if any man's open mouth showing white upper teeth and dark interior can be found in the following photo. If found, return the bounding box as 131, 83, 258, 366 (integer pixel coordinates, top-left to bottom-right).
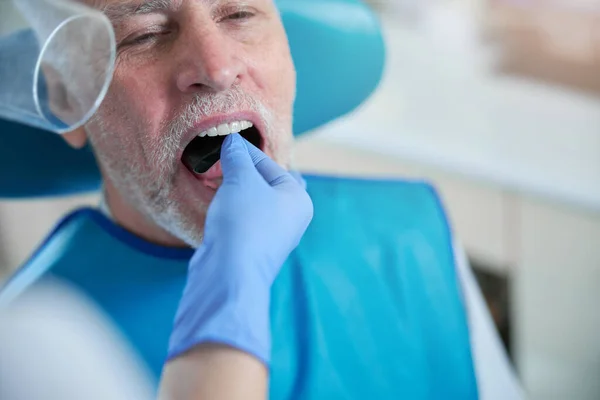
181, 121, 263, 174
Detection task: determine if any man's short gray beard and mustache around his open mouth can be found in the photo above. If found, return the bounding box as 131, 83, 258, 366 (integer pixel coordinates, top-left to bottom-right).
86, 88, 292, 247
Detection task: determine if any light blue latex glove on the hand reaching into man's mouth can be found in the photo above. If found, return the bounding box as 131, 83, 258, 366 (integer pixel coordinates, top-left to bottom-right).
168, 134, 313, 365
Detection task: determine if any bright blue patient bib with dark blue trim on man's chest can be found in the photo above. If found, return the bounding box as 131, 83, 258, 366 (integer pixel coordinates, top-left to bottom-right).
2, 176, 477, 400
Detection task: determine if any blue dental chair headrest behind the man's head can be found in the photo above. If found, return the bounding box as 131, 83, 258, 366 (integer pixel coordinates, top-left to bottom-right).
0, 0, 385, 198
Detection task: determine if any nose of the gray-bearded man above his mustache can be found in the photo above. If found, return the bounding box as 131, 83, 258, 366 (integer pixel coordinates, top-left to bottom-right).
176, 27, 244, 93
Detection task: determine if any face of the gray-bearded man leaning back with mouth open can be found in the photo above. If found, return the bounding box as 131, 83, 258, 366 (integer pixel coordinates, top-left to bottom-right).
86, 0, 295, 245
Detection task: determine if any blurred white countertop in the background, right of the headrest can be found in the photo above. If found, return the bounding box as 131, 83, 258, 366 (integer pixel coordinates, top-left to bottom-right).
314, 5, 600, 210
